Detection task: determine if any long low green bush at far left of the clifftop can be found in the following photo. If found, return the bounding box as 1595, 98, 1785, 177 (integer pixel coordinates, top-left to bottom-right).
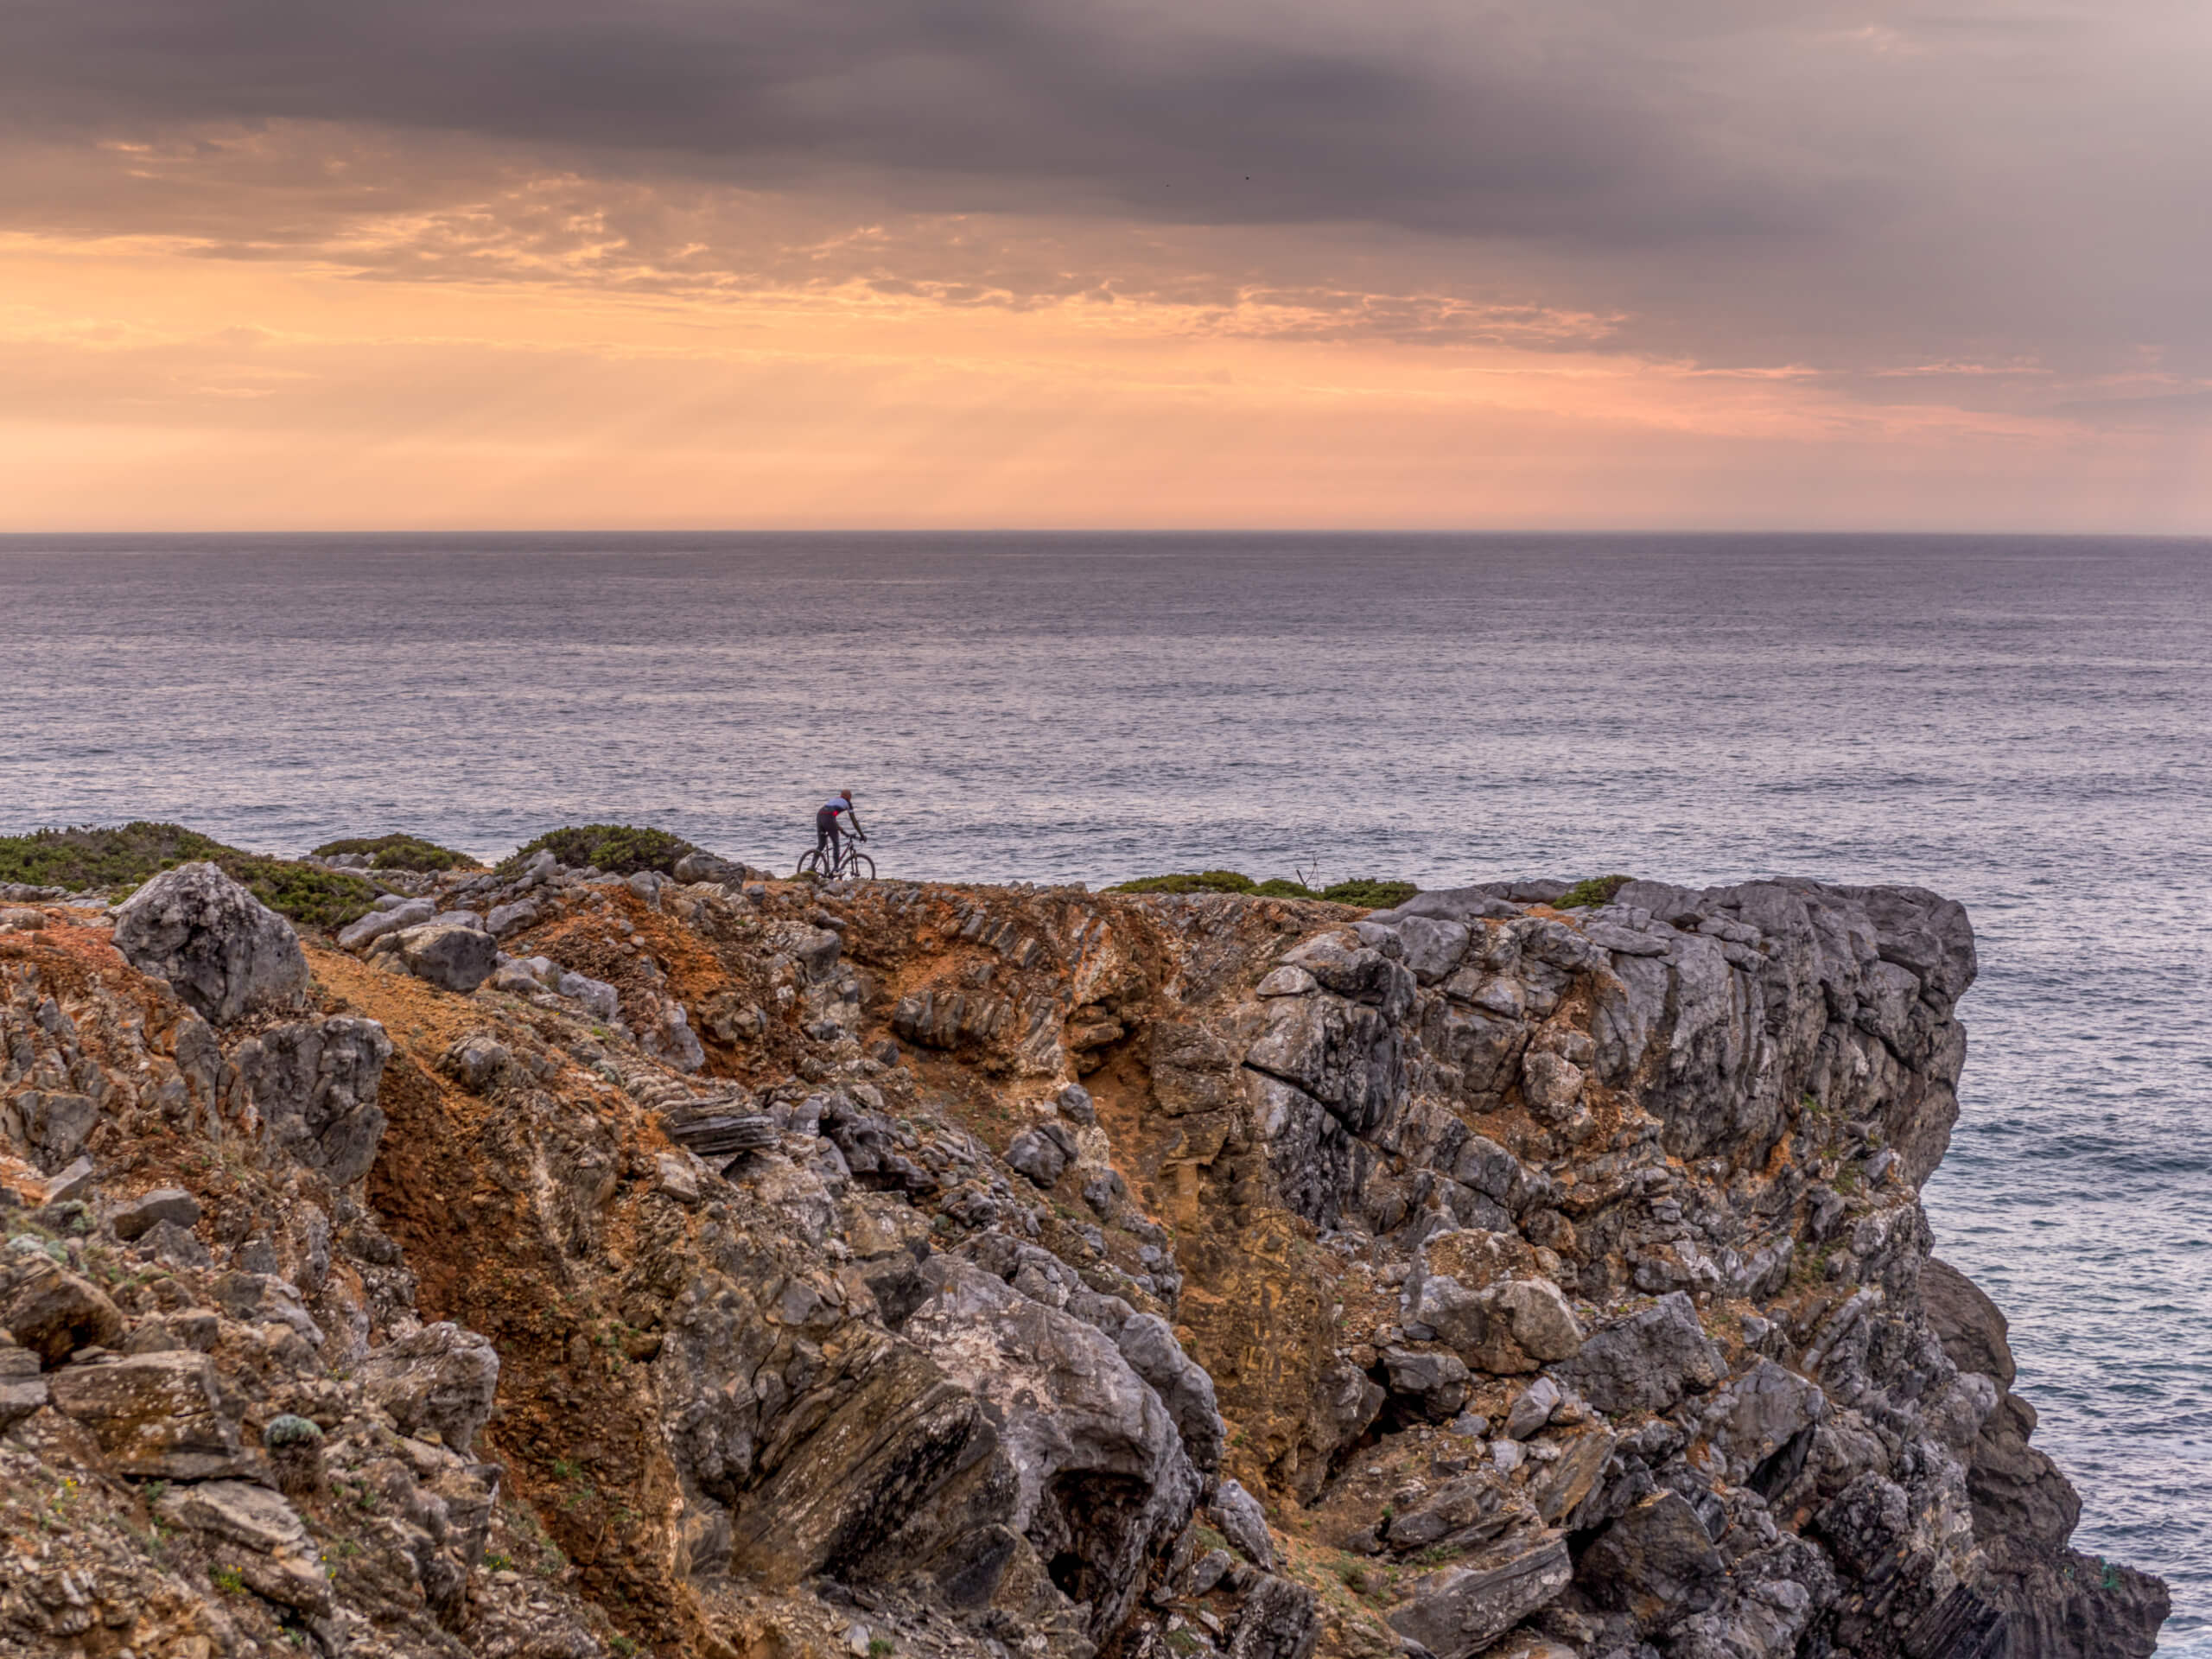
0, 821, 376, 927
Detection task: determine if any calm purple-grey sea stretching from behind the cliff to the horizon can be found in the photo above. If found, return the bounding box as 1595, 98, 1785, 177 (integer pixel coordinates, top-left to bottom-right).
0, 536, 2212, 1655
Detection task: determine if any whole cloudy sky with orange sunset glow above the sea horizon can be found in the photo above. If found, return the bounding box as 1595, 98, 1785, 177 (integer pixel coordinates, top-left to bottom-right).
0, 0, 2212, 533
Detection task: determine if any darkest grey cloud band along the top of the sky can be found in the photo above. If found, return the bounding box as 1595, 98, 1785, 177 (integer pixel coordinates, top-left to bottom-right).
0, 0, 1866, 244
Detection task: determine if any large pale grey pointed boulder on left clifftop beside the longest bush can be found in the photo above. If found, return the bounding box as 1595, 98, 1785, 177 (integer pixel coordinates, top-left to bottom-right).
115, 865, 308, 1024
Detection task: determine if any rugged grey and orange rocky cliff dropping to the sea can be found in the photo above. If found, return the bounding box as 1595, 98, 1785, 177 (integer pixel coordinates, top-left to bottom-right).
0, 856, 2165, 1659
